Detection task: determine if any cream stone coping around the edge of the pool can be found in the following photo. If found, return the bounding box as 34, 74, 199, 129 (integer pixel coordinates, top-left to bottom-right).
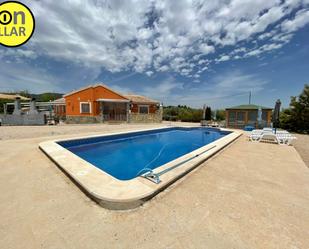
39, 126, 242, 210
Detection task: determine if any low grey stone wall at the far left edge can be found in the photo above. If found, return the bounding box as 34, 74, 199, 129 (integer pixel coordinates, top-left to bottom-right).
0, 113, 46, 125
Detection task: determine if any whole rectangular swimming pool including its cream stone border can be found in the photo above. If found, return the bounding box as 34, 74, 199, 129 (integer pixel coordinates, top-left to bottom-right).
39, 127, 242, 209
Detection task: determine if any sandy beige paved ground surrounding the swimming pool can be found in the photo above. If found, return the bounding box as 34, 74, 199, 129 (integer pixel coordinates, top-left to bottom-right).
0, 124, 309, 249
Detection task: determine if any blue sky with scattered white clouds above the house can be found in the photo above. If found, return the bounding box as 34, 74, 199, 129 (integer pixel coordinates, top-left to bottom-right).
0, 0, 309, 108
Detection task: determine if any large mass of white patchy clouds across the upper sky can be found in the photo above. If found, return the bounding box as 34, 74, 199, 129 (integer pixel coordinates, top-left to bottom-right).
4, 0, 309, 77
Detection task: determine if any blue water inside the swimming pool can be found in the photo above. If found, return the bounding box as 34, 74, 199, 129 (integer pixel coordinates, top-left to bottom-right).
59, 127, 229, 180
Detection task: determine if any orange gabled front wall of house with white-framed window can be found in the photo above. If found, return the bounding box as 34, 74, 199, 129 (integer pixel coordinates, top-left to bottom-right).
65, 86, 125, 116
